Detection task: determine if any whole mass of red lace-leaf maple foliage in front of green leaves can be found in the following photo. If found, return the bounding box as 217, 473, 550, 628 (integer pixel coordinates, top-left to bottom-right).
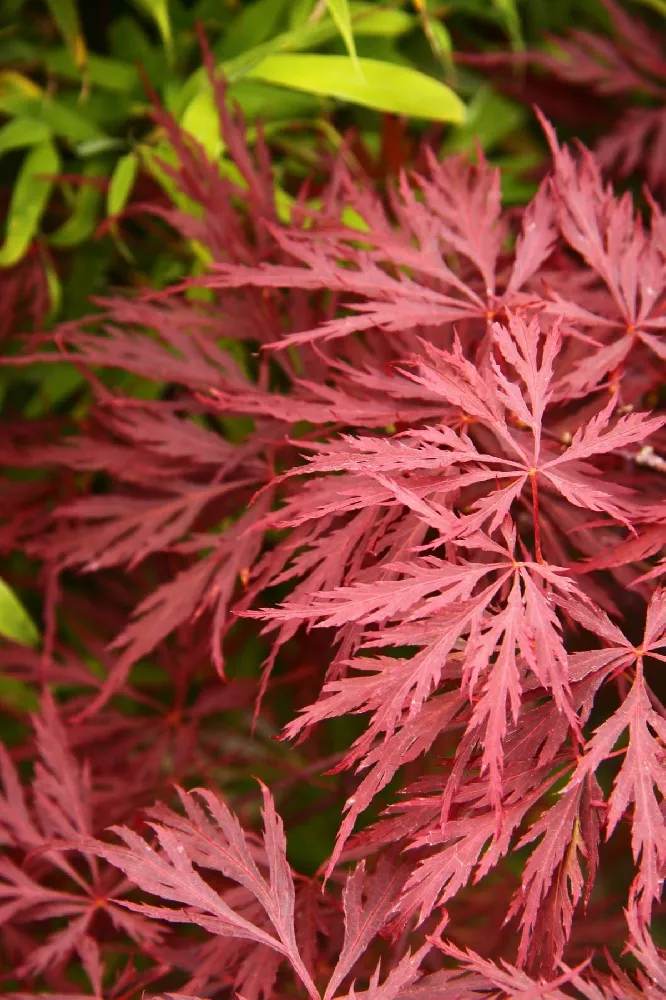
0, 45, 666, 1000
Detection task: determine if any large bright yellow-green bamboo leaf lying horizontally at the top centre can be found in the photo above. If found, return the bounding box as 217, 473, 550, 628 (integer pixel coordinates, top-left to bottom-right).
249, 54, 465, 122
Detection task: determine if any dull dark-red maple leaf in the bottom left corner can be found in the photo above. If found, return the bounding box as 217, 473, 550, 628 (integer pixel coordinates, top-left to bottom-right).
0, 696, 161, 975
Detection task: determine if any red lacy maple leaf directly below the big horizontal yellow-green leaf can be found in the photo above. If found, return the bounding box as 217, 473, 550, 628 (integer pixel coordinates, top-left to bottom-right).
207, 154, 556, 349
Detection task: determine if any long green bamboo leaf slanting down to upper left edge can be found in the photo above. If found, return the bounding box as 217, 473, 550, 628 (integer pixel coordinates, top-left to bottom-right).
0, 141, 60, 267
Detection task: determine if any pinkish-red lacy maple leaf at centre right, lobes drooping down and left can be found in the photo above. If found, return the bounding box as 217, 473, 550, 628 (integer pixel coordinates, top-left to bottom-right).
264, 525, 587, 816
